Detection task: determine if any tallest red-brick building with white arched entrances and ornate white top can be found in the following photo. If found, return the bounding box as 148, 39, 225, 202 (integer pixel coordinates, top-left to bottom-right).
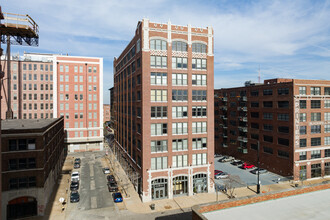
113, 19, 214, 202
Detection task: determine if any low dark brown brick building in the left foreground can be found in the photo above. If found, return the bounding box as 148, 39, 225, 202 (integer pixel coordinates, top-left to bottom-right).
1, 117, 66, 219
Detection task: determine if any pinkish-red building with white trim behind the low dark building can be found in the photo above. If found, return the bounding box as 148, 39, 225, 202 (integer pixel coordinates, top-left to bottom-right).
1, 53, 103, 152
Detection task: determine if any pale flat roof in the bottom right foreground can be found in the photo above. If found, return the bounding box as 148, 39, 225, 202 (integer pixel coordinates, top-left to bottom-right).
202, 189, 330, 220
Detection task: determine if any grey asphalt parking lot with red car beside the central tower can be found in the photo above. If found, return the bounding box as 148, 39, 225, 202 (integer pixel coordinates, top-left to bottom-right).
214, 157, 287, 188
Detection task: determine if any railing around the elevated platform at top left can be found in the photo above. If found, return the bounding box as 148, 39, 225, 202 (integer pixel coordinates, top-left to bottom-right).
3, 13, 39, 35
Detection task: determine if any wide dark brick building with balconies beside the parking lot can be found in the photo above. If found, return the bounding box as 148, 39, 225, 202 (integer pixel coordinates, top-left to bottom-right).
215, 79, 330, 180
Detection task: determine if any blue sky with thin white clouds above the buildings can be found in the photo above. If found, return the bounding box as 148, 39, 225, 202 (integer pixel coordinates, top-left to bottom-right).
0, 0, 330, 104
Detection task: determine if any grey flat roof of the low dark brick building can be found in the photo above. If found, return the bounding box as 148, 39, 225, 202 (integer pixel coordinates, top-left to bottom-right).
1, 118, 58, 130
